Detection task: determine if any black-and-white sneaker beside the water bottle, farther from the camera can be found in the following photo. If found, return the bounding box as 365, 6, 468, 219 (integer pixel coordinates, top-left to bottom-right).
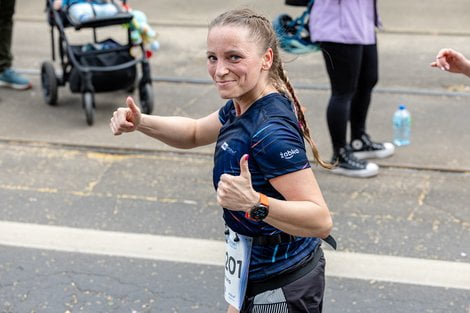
351, 134, 395, 160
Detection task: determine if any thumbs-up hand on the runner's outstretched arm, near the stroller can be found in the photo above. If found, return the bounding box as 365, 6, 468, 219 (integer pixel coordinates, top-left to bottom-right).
109, 97, 142, 136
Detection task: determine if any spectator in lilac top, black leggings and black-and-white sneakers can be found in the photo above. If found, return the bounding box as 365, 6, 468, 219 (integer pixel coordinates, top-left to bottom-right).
309, 0, 394, 177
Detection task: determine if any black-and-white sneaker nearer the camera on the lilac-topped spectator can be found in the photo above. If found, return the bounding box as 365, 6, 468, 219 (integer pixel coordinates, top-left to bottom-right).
331, 145, 379, 177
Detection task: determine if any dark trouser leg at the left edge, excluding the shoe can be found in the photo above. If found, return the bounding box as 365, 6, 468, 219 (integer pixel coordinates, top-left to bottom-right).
0, 0, 15, 73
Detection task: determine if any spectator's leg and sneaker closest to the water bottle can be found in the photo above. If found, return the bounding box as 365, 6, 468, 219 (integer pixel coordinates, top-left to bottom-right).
350, 45, 395, 159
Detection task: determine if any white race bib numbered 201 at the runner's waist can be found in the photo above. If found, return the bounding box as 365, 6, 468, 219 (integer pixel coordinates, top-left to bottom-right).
224, 228, 253, 311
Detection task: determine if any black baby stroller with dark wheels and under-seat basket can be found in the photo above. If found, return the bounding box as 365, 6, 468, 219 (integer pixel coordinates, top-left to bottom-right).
41, 0, 154, 126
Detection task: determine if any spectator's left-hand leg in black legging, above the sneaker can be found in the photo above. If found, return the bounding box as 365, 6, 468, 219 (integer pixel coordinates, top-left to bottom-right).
321, 42, 362, 151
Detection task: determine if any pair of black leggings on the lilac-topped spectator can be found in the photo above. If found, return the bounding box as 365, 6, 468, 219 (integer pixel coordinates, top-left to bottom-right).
321, 42, 378, 151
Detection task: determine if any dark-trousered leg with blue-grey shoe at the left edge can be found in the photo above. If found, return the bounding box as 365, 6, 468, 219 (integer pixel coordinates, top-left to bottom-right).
0, 0, 31, 90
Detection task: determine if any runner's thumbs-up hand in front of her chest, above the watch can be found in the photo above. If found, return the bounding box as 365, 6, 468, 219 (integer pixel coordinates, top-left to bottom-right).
217, 154, 259, 211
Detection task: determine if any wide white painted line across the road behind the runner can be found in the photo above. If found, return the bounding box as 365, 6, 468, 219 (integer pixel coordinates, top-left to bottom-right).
0, 221, 470, 290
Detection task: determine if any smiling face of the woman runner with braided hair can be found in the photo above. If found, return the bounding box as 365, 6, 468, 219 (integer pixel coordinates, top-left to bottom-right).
207, 26, 268, 101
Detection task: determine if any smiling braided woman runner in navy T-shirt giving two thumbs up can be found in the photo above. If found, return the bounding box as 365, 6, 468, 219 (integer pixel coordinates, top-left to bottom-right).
110, 9, 332, 313
